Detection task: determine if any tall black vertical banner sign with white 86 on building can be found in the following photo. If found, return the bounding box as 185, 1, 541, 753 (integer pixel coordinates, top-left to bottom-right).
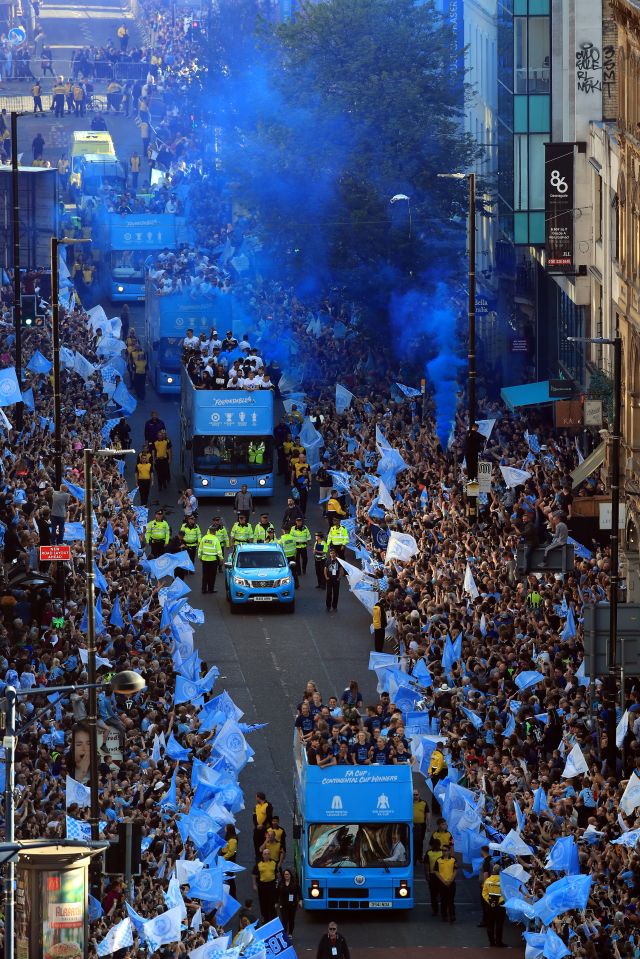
544, 143, 574, 273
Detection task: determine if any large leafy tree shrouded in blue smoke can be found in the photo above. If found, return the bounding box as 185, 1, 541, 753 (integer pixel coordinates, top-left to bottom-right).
229, 0, 475, 292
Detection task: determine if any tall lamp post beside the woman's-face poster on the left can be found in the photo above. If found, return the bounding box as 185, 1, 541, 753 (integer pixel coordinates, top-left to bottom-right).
84, 449, 135, 842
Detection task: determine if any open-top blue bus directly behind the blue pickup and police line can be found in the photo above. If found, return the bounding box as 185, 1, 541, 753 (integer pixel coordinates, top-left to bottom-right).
180, 367, 274, 497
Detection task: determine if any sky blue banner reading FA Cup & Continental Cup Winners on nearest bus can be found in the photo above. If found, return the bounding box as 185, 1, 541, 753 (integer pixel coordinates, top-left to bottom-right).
305, 765, 413, 823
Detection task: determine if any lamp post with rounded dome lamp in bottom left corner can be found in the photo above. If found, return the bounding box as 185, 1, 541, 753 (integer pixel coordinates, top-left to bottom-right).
2, 670, 145, 959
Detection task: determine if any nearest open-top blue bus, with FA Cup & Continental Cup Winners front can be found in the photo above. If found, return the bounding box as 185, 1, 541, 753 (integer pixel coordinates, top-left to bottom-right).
293, 731, 414, 910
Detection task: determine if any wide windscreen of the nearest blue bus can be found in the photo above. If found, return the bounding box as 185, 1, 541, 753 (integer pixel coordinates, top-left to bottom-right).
309, 823, 410, 869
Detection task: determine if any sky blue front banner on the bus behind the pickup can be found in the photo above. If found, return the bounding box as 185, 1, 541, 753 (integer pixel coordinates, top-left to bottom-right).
190, 390, 273, 436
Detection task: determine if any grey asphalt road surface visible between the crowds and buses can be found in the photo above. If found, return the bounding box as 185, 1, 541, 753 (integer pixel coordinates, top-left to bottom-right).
0, 0, 521, 959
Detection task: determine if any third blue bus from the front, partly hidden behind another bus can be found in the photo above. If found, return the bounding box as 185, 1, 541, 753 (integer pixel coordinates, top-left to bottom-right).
144, 277, 232, 396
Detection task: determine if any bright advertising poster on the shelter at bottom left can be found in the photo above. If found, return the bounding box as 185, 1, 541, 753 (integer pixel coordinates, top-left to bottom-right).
41, 868, 86, 959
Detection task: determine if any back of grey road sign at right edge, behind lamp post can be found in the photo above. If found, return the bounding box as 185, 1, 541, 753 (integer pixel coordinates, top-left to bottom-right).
583, 603, 640, 676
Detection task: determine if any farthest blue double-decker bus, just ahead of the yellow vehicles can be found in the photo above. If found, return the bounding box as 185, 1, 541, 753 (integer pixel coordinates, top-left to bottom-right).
101, 213, 189, 303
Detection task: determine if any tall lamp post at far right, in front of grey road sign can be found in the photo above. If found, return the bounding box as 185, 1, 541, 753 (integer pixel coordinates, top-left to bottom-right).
567, 329, 622, 775
